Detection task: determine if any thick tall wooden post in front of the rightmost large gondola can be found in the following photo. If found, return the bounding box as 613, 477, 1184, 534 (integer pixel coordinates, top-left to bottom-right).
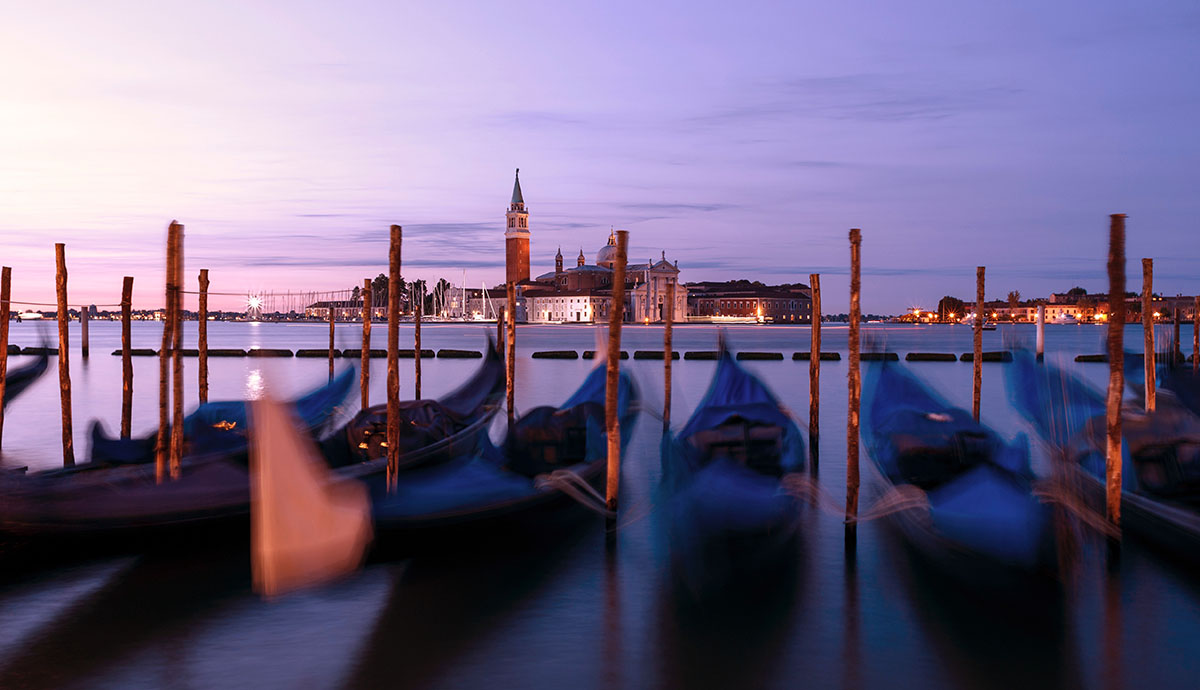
1104, 214, 1126, 527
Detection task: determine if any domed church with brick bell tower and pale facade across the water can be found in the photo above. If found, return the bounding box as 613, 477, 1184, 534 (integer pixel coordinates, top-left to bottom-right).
504, 168, 688, 323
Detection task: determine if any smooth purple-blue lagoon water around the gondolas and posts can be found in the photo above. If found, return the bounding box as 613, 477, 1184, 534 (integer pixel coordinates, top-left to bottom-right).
0, 322, 1200, 689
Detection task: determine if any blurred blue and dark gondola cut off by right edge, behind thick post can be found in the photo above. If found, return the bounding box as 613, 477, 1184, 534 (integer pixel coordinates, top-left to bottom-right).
1008, 348, 1200, 564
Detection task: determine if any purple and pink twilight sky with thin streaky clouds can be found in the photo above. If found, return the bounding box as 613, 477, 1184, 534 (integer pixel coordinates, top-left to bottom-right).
0, 0, 1200, 313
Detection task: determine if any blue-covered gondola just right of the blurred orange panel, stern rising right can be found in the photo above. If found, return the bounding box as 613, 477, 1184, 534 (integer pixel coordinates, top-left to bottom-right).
367, 365, 637, 550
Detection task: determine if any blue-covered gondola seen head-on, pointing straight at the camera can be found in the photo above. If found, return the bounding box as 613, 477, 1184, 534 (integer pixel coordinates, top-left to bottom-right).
662, 346, 806, 598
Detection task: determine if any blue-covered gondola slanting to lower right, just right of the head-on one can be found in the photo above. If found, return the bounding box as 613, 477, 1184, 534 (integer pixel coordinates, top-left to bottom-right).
863, 355, 1057, 592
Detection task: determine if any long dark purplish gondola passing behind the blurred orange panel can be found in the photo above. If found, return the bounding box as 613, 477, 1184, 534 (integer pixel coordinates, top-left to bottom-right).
0, 340, 504, 546
